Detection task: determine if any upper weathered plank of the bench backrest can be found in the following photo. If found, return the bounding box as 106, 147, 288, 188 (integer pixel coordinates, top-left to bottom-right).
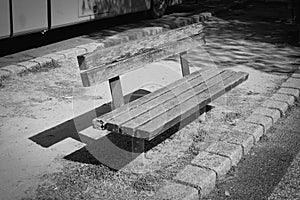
77, 23, 203, 70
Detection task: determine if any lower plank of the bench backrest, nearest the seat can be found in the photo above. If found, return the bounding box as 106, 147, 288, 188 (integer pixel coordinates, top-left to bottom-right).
81, 33, 203, 87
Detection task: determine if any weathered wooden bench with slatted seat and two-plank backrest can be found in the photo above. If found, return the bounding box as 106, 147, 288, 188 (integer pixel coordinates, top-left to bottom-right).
78, 23, 248, 140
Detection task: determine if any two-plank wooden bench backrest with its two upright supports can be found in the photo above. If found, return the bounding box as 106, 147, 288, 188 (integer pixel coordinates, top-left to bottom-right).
77, 23, 204, 109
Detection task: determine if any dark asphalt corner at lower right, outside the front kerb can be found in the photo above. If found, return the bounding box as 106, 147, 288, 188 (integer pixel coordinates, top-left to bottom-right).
205, 104, 300, 200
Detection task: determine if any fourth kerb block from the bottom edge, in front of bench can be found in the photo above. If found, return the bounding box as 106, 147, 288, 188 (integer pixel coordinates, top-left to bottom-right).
205, 141, 243, 166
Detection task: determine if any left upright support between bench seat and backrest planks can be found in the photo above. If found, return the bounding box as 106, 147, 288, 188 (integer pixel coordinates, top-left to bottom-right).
109, 76, 124, 110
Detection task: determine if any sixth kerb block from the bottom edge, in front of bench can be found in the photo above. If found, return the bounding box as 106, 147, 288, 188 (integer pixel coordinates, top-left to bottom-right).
232, 121, 264, 143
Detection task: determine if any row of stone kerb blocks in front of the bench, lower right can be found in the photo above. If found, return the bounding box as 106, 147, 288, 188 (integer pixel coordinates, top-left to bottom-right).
156, 68, 300, 200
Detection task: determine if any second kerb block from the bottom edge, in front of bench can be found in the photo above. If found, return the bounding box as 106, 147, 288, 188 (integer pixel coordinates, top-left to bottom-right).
174, 165, 216, 196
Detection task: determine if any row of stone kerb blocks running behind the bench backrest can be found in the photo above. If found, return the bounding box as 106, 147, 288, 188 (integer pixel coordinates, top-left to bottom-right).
0, 12, 211, 82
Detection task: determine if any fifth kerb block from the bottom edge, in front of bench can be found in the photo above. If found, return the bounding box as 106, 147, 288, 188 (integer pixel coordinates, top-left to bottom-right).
225, 130, 254, 155
